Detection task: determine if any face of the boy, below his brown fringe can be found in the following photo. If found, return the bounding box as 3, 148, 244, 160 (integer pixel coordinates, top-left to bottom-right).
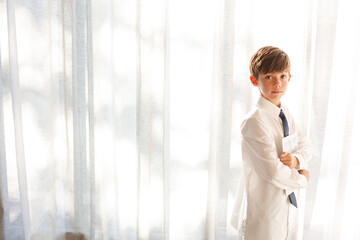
250, 71, 291, 107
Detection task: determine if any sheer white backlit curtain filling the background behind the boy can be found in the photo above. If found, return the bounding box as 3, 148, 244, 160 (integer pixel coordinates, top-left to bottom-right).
0, 0, 360, 240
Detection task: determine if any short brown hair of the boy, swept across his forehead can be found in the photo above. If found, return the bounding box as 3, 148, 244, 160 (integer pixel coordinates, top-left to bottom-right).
249, 46, 290, 79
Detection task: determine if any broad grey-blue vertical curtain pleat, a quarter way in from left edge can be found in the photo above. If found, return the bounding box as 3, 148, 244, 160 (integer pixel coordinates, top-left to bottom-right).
72, 1, 89, 233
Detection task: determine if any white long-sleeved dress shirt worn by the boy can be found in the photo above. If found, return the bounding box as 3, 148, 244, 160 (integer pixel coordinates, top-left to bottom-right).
232, 97, 311, 240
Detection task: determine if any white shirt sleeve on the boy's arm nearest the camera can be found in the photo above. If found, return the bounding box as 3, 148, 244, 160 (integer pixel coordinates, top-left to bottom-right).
241, 118, 307, 190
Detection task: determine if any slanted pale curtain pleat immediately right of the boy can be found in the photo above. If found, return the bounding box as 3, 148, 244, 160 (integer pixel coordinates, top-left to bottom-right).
304, 0, 338, 237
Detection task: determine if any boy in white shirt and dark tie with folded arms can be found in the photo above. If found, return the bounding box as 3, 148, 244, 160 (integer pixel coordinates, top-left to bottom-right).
233, 46, 310, 240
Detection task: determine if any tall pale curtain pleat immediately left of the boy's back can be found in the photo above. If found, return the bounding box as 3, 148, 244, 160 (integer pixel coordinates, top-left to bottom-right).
206, 0, 235, 239
